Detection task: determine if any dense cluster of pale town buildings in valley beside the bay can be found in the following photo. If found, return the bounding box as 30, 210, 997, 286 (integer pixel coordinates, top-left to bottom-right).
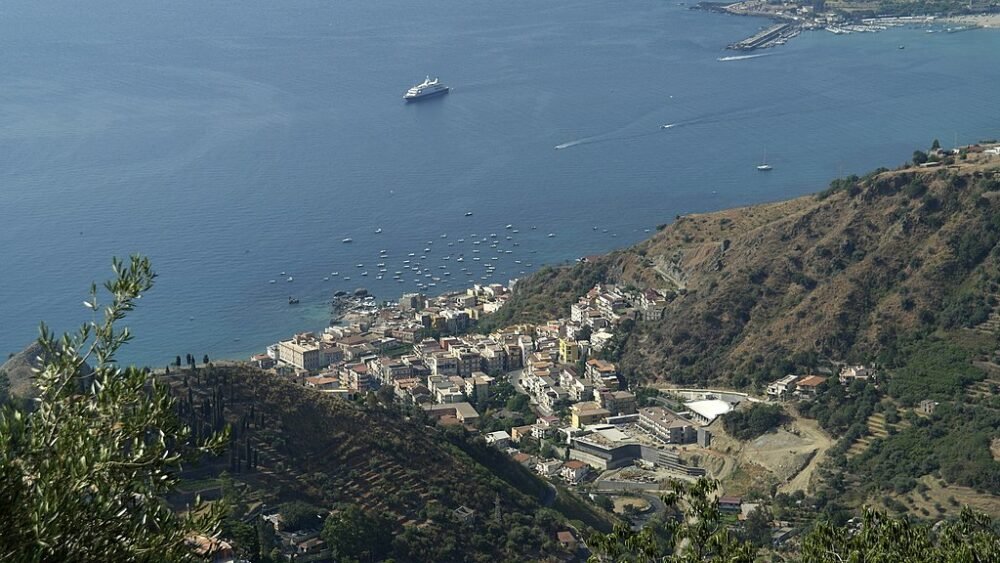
251, 280, 877, 548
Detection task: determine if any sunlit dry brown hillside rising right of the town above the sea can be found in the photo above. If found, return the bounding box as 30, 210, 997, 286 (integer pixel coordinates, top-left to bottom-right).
503, 150, 1000, 386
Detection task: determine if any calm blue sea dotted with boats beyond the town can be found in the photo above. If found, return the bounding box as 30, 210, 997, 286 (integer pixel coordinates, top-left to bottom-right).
0, 0, 1000, 364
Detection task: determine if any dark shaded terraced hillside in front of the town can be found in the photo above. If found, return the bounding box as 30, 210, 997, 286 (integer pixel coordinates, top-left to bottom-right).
164, 366, 600, 561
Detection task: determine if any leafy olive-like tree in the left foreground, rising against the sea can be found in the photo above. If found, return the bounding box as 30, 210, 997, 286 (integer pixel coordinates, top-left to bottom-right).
0, 256, 226, 562
